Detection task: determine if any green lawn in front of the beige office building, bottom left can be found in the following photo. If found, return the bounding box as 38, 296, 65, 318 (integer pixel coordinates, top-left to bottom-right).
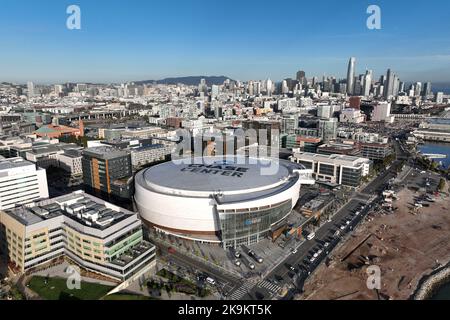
28, 276, 113, 300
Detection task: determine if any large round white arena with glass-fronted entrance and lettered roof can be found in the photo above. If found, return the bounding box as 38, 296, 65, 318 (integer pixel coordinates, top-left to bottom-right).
135, 156, 314, 248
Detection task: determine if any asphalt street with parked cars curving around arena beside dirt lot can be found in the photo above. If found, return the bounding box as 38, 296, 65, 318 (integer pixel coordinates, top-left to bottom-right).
155, 140, 408, 300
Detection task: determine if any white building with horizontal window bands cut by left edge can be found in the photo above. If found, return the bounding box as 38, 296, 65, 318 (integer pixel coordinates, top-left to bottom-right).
0, 158, 48, 210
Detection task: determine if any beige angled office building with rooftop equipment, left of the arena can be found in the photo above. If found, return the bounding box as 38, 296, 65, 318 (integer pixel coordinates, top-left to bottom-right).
0, 191, 155, 281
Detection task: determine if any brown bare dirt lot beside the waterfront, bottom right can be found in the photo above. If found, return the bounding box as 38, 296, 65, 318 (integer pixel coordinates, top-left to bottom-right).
300, 189, 450, 300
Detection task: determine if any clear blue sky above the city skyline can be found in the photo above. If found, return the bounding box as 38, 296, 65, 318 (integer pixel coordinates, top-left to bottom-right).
0, 0, 450, 83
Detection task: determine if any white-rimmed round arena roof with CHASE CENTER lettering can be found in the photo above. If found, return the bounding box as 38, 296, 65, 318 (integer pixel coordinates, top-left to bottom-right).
139, 157, 303, 197
